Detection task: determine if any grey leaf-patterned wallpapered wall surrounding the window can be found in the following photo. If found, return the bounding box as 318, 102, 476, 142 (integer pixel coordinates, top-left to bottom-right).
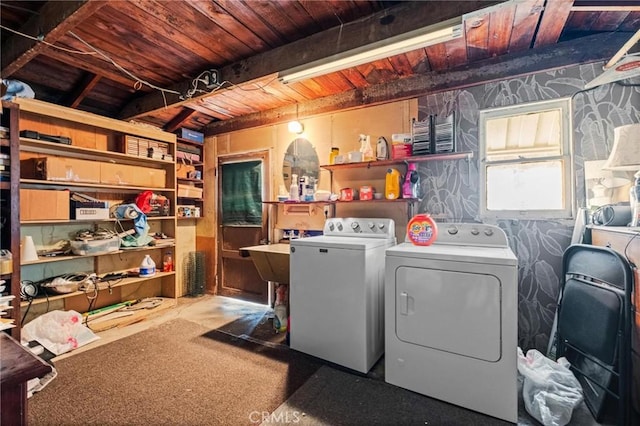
418, 63, 640, 353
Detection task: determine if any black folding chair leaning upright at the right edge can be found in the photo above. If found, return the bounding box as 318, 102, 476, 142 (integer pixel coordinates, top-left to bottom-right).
556, 244, 634, 426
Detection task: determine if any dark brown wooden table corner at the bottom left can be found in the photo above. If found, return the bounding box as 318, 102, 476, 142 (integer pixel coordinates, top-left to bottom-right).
0, 333, 53, 425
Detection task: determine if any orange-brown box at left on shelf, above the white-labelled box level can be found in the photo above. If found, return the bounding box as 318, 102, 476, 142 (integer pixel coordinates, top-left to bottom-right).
20, 189, 69, 220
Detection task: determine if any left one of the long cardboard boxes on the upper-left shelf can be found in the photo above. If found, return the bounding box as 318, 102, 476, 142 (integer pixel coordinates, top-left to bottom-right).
20, 157, 100, 183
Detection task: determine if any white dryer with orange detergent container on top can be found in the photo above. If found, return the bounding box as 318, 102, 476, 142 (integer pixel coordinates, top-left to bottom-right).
385, 223, 518, 423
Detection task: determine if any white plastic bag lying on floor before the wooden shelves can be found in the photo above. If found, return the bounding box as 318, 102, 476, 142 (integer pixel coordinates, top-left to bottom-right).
21, 311, 99, 355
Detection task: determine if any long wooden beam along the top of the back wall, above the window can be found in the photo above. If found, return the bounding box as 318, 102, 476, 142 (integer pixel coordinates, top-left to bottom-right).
204, 33, 629, 136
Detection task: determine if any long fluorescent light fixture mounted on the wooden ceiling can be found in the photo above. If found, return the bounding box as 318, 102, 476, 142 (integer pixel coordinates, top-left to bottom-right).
278, 17, 462, 83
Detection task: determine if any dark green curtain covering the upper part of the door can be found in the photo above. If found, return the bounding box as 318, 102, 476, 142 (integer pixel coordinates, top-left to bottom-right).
221, 161, 262, 226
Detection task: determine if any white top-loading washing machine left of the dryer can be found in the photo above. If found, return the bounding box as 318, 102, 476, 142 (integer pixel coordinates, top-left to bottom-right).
289, 218, 396, 373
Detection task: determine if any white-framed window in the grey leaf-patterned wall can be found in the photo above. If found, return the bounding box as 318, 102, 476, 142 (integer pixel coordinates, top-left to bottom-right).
479, 98, 573, 219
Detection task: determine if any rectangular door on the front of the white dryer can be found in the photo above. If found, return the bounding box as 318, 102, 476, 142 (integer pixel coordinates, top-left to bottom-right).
395, 266, 502, 362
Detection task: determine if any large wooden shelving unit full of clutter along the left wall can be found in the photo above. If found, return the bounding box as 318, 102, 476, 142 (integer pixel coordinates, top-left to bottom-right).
12, 99, 182, 321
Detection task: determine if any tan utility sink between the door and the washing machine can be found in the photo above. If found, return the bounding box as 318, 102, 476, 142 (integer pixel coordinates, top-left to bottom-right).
240, 243, 291, 284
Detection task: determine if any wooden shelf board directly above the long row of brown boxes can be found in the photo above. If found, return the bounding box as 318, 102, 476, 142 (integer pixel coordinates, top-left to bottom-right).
20, 138, 174, 166
